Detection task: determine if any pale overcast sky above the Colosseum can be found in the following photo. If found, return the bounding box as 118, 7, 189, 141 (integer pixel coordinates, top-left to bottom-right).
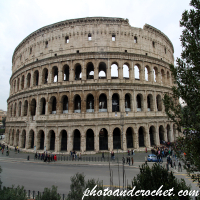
0, 0, 191, 110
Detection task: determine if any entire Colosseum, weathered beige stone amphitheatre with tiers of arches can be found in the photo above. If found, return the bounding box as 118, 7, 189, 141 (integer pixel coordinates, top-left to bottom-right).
6, 17, 178, 154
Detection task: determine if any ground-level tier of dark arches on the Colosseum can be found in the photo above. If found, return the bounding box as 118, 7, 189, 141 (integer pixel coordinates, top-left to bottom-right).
6, 122, 180, 153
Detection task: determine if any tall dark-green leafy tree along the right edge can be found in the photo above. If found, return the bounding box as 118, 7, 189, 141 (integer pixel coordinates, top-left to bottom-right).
164, 0, 200, 184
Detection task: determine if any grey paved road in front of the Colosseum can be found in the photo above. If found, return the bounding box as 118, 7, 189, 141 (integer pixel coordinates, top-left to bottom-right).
0, 148, 199, 198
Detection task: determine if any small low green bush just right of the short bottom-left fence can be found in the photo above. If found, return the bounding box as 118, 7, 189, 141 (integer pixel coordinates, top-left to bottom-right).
36, 185, 61, 200
